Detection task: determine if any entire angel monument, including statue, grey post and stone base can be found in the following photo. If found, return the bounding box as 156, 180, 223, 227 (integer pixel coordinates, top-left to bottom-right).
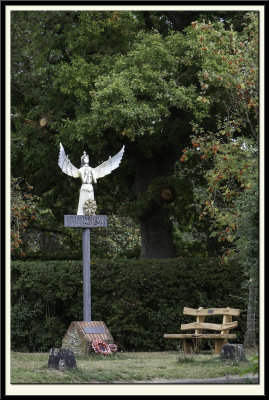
58, 143, 124, 354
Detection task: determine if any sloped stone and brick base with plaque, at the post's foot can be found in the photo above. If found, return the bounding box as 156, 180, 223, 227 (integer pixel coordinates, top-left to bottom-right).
62, 321, 114, 356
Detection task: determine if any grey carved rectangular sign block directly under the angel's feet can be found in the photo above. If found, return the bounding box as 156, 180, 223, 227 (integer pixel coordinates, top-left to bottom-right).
64, 215, 107, 228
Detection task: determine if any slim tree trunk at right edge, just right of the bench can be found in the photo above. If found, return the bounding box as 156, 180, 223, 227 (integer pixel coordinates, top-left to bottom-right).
244, 278, 257, 347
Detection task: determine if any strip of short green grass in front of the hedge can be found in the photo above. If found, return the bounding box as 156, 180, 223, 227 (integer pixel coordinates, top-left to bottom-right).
11, 349, 257, 384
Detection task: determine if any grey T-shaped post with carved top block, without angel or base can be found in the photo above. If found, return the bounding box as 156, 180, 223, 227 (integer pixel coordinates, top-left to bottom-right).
64, 215, 107, 322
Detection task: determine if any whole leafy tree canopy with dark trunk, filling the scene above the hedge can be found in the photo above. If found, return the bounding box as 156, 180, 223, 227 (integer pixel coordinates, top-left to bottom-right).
11, 11, 258, 257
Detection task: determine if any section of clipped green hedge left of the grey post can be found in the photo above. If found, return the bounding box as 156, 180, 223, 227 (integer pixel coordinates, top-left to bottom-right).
11, 262, 82, 351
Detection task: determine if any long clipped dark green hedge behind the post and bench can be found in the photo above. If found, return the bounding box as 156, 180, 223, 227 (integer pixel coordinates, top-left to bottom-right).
11, 258, 247, 351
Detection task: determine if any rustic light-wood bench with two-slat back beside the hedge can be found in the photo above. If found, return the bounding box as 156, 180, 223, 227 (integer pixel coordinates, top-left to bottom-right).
164, 307, 240, 355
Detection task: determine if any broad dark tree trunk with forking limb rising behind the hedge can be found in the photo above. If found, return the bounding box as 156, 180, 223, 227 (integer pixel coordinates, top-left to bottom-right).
129, 109, 192, 258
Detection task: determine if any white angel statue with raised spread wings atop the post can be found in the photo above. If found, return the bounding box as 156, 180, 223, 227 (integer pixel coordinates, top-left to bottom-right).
58, 143, 125, 215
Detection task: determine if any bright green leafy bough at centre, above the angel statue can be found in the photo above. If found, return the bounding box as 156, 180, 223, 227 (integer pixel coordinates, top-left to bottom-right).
79, 31, 207, 141
